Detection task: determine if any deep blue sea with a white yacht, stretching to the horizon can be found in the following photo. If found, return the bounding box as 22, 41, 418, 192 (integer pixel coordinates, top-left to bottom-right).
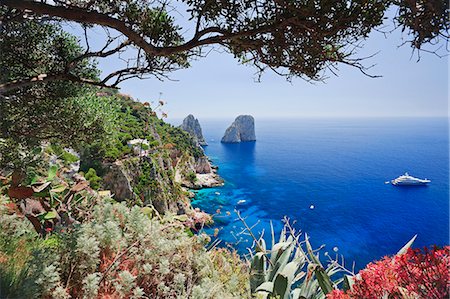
188, 118, 449, 270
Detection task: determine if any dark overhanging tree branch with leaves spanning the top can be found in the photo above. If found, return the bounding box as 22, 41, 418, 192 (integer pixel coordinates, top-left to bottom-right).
0, 0, 450, 92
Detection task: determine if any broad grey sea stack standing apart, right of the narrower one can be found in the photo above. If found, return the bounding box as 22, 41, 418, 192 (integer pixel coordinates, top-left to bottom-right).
222, 115, 256, 143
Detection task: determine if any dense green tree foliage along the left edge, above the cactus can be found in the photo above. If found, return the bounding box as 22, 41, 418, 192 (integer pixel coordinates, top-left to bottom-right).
0, 19, 117, 169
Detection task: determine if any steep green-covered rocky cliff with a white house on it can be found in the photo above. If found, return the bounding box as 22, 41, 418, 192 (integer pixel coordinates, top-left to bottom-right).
82, 97, 218, 214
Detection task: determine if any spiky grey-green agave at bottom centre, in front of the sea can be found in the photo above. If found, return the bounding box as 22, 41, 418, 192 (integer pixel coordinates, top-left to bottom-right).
238, 213, 350, 299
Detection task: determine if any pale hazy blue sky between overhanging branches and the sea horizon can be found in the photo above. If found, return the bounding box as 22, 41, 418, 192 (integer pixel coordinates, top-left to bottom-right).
82, 8, 449, 121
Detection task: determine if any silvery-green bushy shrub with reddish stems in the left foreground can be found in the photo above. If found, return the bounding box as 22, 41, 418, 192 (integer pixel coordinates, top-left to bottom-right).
0, 199, 250, 299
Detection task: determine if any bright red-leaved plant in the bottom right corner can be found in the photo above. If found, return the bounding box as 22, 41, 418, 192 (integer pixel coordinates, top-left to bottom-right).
327, 246, 450, 299
